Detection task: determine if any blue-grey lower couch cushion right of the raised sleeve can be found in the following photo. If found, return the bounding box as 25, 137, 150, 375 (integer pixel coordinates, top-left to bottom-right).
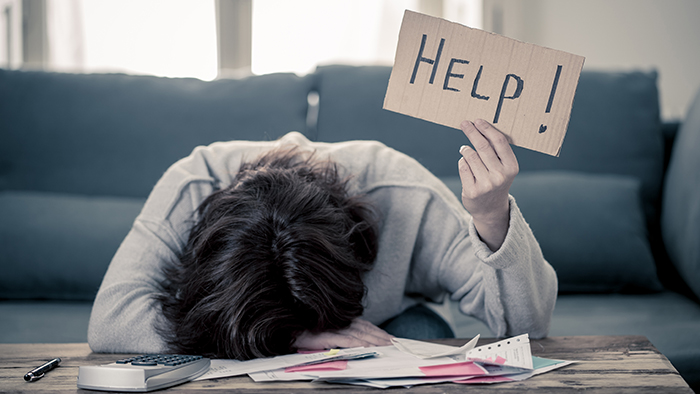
511, 172, 661, 292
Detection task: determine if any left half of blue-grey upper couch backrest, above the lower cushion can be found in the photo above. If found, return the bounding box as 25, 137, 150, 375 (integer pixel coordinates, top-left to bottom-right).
0, 70, 312, 197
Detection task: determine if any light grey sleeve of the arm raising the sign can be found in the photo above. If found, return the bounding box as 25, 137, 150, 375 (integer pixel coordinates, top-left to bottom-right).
439, 196, 557, 338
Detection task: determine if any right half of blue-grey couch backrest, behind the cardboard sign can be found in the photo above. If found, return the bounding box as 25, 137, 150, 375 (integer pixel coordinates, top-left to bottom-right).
316, 66, 663, 219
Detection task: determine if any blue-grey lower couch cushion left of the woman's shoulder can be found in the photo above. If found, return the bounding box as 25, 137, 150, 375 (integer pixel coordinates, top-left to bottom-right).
0, 191, 145, 300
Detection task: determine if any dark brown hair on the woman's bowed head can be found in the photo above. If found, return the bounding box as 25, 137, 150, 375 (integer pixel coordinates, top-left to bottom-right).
156, 148, 377, 359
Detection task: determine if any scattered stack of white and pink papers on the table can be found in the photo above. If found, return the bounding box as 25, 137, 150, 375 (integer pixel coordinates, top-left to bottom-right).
197, 334, 573, 388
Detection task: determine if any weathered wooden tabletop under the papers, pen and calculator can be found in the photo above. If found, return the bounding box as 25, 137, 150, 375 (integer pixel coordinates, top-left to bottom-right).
0, 336, 693, 394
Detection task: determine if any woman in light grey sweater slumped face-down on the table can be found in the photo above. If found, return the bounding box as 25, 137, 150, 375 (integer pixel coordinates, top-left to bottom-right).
88, 120, 557, 359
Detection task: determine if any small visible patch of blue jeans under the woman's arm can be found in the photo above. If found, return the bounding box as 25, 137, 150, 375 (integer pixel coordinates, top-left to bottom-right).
379, 304, 455, 339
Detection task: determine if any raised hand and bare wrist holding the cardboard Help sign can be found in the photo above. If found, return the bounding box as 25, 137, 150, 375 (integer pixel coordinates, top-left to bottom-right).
459, 119, 519, 252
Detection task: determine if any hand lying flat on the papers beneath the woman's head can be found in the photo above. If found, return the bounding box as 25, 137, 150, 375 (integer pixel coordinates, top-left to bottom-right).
294, 319, 392, 350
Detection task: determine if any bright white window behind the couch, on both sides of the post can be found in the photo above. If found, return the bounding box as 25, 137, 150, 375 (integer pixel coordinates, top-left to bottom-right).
32, 0, 483, 80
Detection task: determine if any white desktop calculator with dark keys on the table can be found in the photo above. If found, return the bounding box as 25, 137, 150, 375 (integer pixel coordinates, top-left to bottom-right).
78, 354, 211, 392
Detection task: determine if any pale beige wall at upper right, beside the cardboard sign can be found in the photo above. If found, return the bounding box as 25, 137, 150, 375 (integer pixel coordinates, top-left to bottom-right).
484, 0, 700, 120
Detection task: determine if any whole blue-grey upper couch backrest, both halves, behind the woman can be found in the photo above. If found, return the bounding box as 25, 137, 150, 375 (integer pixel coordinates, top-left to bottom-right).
0, 66, 663, 209
